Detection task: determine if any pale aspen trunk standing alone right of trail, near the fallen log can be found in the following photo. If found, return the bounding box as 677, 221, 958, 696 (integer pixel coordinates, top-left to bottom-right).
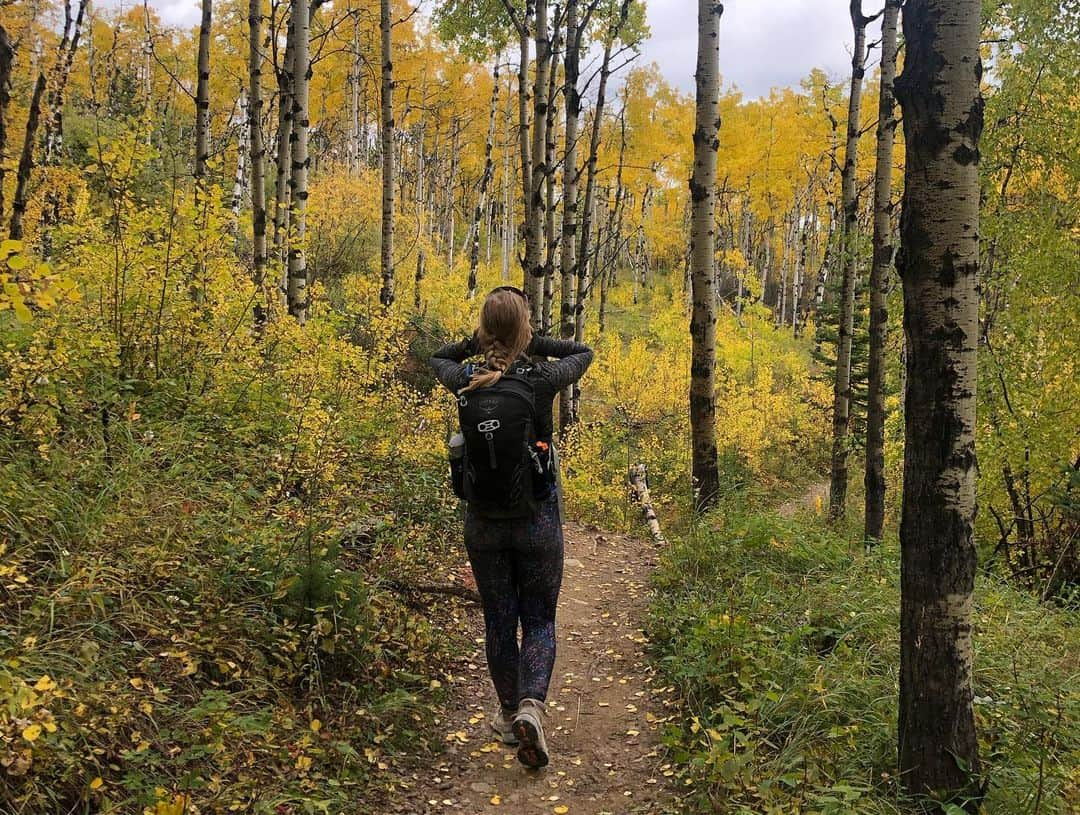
690, 0, 724, 512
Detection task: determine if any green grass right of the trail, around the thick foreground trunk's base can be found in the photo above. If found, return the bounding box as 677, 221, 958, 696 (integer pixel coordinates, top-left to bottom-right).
651, 497, 1080, 815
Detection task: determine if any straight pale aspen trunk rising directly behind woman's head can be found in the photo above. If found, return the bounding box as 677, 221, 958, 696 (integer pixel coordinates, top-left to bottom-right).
524, 0, 551, 329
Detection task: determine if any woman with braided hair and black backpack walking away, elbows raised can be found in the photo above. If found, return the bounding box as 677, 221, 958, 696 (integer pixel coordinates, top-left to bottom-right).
431, 286, 593, 769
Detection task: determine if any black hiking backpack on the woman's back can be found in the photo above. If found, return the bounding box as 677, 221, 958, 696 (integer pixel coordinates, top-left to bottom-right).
458, 365, 539, 518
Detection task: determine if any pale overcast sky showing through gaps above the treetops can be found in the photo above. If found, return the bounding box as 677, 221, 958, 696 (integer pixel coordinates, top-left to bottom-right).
120, 0, 859, 97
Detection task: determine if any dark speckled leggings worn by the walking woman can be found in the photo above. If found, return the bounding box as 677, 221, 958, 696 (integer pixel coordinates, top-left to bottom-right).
465, 495, 563, 710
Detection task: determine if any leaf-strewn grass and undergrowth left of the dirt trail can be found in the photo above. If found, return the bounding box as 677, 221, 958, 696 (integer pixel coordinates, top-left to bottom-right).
0, 392, 473, 815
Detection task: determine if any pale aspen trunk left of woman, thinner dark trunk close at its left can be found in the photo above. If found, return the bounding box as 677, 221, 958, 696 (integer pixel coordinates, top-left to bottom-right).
286, 0, 311, 325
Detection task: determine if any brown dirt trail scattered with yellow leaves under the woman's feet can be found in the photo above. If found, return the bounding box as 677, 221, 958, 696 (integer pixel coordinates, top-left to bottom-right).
379, 524, 674, 815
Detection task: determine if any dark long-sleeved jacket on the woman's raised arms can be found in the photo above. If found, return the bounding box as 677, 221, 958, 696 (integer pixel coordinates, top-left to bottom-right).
431, 337, 593, 442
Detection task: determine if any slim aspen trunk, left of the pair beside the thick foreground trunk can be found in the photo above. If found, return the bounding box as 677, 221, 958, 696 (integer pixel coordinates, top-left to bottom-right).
828, 0, 869, 520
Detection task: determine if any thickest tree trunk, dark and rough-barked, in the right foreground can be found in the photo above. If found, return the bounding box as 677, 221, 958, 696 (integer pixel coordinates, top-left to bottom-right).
895, 0, 983, 797
